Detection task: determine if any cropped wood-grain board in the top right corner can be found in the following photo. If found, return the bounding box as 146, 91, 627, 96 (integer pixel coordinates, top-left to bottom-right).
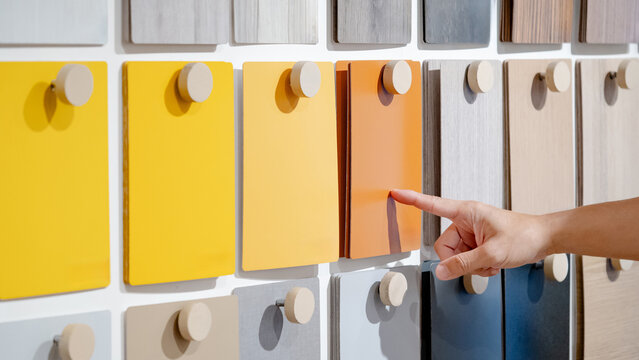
579, 0, 639, 44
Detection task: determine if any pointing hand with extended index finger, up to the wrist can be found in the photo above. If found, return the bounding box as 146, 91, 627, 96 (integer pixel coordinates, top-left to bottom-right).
391, 190, 552, 280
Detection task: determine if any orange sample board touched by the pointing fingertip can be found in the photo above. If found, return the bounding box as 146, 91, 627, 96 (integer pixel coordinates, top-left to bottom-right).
336, 61, 423, 258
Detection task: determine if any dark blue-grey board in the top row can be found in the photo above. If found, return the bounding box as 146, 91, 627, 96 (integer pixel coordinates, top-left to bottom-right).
423, 0, 490, 44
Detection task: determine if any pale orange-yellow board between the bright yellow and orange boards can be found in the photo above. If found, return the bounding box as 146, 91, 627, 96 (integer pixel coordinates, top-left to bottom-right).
242, 62, 339, 271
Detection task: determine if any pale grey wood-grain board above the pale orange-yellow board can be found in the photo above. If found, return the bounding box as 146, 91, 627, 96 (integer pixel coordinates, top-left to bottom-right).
233, 0, 317, 44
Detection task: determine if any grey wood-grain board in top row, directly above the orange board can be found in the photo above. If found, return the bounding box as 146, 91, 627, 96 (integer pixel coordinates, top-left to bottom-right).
332, 0, 411, 44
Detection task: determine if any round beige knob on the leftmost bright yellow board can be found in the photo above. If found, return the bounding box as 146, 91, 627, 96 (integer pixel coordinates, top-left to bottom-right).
51, 64, 93, 106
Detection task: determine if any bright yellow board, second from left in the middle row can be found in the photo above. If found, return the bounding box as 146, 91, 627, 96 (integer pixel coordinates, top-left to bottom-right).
123, 62, 235, 285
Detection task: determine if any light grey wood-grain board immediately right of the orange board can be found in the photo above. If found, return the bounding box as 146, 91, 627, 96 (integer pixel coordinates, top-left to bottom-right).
424, 60, 506, 245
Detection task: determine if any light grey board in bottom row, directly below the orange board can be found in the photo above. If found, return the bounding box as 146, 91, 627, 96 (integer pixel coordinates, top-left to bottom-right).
330, 266, 421, 360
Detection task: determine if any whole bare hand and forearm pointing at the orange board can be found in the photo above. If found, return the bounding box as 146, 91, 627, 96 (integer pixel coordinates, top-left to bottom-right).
391, 190, 639, 280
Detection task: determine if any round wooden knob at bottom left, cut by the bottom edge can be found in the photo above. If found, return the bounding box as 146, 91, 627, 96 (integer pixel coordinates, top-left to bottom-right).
58, 324, 95, 360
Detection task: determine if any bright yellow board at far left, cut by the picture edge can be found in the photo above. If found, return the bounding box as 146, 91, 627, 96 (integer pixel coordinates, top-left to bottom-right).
0, 62, 109, 299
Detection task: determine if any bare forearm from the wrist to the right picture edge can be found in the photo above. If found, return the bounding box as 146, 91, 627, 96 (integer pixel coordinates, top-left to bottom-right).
542, 198, 639, 260
